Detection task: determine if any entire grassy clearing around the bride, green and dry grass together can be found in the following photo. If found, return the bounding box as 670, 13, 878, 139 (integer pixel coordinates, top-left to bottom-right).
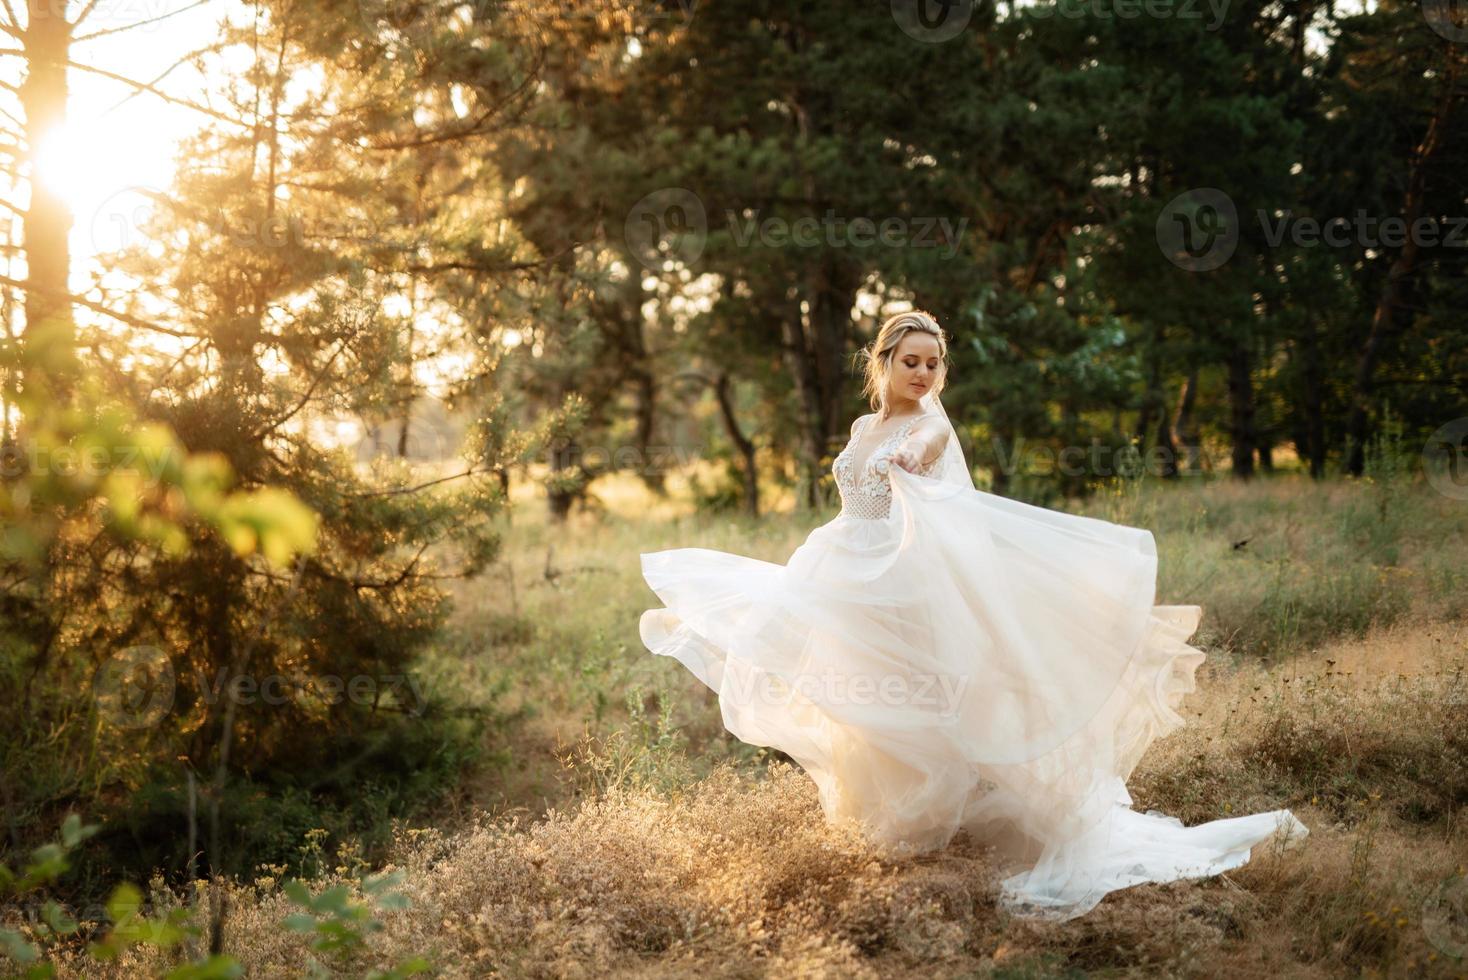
45, 477, 1468, 979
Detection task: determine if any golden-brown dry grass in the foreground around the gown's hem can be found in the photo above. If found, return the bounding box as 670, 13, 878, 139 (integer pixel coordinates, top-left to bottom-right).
51, 624, 1468, 977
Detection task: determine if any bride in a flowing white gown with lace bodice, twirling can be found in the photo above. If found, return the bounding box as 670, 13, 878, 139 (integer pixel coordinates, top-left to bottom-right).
640, 311, 1308, 920
